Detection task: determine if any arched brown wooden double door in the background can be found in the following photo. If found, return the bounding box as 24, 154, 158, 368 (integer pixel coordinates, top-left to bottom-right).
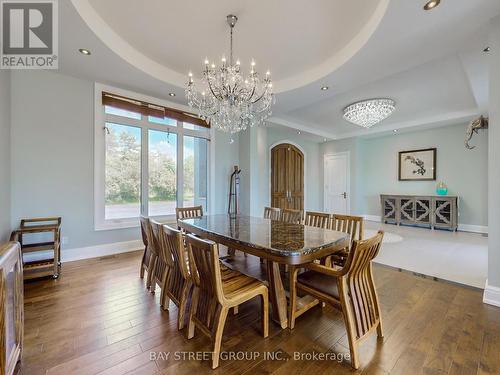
271, 143, 304, 210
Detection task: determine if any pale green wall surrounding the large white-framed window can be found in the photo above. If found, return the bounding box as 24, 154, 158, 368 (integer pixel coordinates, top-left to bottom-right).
11, 70, 238, 251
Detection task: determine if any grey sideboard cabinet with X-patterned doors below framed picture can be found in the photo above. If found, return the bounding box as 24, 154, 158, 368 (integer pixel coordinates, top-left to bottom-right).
380, 195, 458, 231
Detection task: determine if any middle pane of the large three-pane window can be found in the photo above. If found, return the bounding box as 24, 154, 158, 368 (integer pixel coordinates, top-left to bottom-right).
148, 130, 177, 216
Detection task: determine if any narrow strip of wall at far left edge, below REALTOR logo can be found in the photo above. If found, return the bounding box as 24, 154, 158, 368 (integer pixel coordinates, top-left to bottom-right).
0, 70, 12, 243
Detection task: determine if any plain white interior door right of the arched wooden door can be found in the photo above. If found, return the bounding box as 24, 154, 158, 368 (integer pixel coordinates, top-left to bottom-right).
324, 152, 350, 214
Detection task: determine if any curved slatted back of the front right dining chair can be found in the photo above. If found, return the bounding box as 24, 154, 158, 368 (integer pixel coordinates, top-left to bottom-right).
346, 231, 384, 338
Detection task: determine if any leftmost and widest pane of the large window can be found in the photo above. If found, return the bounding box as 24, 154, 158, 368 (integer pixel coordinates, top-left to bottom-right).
105, 123, 141, 219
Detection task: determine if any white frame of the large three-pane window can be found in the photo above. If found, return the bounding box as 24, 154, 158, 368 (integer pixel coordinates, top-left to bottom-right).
94, 82, 214, 231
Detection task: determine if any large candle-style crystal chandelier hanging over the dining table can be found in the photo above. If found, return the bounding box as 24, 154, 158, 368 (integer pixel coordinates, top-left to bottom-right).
186, 15, 274, 133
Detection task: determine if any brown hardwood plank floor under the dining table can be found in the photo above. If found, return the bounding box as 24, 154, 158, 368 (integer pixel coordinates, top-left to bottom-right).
20, 248, 500, 375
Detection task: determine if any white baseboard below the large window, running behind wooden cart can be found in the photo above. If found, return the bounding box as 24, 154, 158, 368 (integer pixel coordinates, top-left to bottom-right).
24, 240, 144, 263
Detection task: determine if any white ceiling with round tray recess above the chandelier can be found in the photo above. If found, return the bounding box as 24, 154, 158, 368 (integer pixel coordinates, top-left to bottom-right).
59, 0, 500, 141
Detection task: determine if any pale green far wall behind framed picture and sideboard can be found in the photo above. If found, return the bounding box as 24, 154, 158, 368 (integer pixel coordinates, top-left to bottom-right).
322, 124, 488, 226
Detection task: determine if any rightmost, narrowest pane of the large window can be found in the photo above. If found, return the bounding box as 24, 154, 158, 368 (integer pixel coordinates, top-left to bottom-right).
183, 136, 208, 211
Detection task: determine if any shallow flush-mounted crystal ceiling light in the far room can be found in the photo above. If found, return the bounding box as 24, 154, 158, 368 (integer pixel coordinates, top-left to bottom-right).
344, 99, 396, 128
